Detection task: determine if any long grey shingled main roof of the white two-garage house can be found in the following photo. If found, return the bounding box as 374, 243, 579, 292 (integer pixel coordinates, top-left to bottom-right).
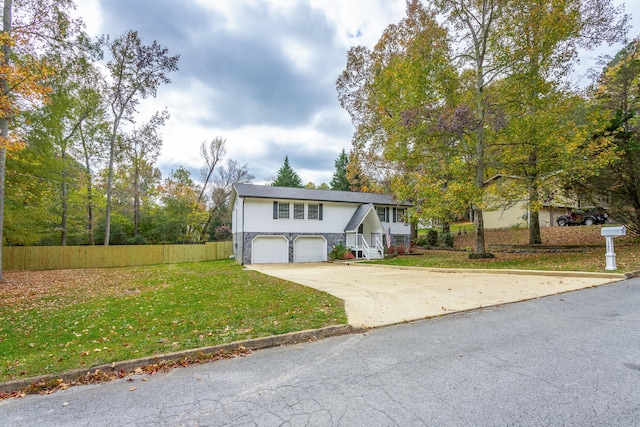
233, 184, 411, 206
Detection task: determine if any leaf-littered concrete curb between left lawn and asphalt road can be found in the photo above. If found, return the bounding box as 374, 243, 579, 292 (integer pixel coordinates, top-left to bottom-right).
0, 325, 356, 393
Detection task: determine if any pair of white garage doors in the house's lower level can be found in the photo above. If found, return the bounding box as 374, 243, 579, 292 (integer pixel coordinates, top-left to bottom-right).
251, 235, 327, 264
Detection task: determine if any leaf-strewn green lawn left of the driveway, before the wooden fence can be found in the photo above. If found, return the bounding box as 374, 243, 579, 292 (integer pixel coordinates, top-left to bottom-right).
0, 260, 347, 381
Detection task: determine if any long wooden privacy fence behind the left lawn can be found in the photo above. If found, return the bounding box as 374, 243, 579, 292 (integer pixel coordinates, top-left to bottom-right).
2, 242, 233, 271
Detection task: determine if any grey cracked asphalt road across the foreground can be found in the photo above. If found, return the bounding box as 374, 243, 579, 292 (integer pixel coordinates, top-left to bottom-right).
0, 278, 640, 426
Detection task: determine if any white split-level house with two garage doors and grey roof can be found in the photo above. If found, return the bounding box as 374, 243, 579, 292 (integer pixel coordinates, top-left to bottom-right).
231, 184, 411, 264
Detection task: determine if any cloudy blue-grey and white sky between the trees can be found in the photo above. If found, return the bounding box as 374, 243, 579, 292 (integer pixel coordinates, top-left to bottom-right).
77, 0, 640, 184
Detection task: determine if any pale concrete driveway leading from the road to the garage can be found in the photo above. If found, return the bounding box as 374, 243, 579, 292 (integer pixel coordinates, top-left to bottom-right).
247, 263, 625, 327
